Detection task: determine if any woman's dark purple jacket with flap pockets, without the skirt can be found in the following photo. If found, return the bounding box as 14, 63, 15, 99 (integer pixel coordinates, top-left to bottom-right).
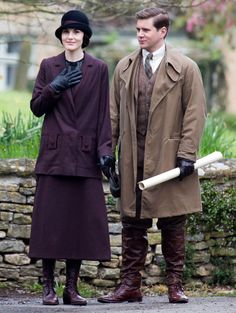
30, 53, 112, 177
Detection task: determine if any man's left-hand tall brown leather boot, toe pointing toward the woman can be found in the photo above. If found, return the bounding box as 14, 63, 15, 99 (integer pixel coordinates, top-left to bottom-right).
97, 227, 148, 303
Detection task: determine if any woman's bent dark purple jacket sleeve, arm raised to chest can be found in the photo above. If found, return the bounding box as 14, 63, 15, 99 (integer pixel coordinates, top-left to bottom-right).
30, 59, 61, 117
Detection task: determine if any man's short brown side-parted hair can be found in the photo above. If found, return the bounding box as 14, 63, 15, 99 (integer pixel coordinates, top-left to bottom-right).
135, 7, 170, 31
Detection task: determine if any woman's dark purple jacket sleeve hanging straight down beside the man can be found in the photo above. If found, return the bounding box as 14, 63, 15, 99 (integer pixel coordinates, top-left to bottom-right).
97, 64, 112, 157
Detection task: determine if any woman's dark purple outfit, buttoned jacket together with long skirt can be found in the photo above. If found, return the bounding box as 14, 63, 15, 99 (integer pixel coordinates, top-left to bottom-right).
29, 53, 111, 260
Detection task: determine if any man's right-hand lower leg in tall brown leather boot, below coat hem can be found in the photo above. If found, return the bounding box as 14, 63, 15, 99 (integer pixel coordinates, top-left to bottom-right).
161, 216, 188, 303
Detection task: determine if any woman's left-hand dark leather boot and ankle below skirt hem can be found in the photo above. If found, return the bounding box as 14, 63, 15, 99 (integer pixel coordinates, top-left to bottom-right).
42, 259, 59, 305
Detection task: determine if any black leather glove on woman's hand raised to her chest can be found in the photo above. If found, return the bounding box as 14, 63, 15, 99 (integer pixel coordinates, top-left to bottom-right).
50, 68, 82, 92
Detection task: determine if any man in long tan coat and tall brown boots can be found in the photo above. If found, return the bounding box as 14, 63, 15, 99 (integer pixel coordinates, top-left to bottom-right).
98, 8, 205, 303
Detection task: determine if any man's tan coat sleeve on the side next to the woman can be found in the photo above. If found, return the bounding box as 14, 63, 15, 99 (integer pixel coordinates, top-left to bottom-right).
110, 67, 120, 155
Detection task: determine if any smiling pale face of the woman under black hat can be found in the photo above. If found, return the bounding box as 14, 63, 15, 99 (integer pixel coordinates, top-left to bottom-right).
61, 28, 84, 52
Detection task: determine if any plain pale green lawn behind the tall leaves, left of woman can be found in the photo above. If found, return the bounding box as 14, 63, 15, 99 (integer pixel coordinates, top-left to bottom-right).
0, 91, 32, 120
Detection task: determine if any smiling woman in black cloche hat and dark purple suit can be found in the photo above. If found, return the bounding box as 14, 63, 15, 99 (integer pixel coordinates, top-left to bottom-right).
29, 10, 114, 305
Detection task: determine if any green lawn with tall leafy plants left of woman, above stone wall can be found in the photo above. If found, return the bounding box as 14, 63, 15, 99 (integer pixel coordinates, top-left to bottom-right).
0, 91, 41, 159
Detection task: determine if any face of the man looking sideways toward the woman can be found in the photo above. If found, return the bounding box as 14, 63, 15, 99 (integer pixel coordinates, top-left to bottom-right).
136, 17, 167, 52
